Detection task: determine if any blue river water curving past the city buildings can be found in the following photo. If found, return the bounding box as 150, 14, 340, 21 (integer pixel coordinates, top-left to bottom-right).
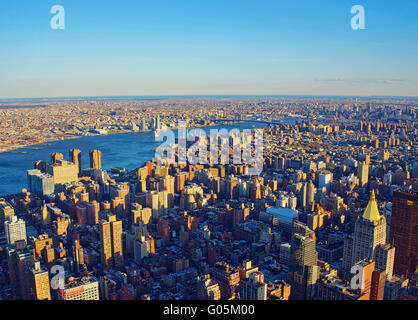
0, 118, 297, 196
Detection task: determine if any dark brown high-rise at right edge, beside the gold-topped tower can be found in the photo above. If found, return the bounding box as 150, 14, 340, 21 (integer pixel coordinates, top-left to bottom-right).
389, 190, 418, 277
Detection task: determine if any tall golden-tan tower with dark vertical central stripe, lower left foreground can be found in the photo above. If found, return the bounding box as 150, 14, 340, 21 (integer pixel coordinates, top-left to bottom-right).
99, 215, 123, 267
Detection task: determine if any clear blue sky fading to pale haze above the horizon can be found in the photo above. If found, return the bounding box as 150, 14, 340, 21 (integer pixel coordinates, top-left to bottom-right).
0, 0, 418, 98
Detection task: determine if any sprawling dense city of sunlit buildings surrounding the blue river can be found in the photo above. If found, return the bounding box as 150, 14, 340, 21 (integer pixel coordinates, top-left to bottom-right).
0, 97, 418, 300
